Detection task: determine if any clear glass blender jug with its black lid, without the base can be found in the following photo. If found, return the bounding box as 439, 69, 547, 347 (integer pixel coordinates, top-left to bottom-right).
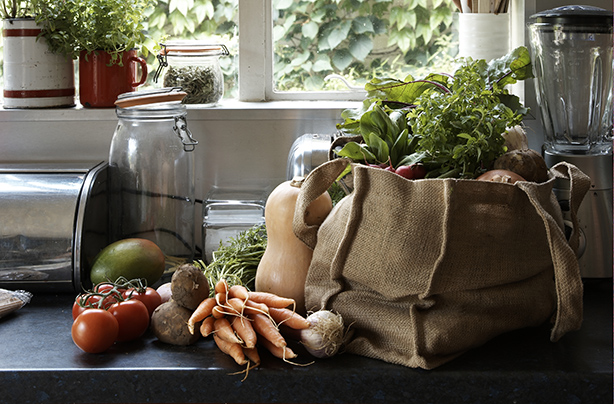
529, 6, 612, 154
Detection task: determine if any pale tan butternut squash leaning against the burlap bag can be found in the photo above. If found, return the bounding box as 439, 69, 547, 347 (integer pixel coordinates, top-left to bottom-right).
255, 177, 332, 315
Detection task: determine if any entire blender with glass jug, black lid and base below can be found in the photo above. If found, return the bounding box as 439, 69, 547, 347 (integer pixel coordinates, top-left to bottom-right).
529, 6, 613, 278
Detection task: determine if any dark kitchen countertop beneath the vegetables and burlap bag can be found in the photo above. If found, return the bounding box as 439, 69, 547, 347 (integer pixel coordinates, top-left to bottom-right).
0, 279, 613, 404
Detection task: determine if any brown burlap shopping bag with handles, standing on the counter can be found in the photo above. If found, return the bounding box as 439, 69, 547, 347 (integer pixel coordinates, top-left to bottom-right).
293, 159, 590, 369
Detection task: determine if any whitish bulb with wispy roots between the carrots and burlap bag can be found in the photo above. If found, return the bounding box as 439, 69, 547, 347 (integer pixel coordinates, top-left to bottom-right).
300, 310, 345, 358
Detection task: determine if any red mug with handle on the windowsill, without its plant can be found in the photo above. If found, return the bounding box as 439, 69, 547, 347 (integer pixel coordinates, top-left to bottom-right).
79, 50, 147, 108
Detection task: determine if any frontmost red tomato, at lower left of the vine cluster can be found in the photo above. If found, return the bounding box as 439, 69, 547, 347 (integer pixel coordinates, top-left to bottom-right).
71, 309, 119, 353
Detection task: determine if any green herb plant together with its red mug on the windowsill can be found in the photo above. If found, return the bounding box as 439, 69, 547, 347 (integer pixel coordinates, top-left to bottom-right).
31, 0, 154, 108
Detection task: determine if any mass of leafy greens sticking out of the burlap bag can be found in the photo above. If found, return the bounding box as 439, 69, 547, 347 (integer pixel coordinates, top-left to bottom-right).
336, 47, 532, 178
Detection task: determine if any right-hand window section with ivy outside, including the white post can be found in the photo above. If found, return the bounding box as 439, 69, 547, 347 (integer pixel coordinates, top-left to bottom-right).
239, 0, 457, 100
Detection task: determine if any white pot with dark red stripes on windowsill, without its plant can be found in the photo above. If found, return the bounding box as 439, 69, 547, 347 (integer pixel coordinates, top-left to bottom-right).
2, 18, 75, 108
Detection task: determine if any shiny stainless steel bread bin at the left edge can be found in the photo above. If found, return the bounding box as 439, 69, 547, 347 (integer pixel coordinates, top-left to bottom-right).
0, 162, 108, 292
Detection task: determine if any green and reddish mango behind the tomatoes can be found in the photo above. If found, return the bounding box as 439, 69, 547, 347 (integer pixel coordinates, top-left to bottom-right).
90, 238, 165, 286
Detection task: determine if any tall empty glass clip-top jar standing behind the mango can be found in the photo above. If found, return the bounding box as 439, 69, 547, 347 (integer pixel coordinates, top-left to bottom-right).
109, 88, 198, 280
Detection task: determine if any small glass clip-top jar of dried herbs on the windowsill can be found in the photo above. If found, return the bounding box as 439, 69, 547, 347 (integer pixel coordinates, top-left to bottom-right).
154, 41, 229, 106
